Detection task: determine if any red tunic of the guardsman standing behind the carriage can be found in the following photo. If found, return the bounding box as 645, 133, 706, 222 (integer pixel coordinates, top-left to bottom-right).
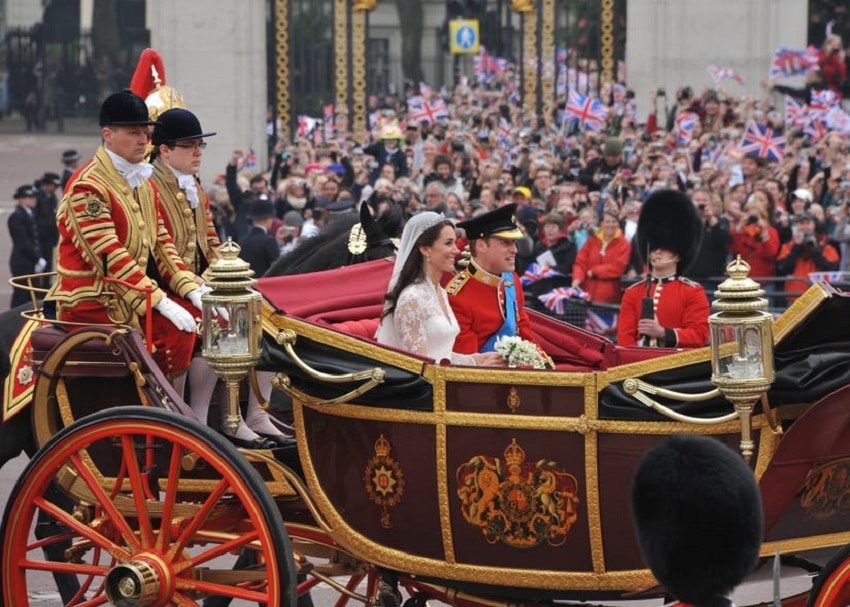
617, 276, 710, 348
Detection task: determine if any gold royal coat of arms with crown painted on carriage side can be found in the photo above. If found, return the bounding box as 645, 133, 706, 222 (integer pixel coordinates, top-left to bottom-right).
456, 439, 579, 548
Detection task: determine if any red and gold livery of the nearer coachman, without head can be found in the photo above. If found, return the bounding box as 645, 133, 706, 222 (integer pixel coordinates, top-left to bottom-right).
46, 147, 198, 373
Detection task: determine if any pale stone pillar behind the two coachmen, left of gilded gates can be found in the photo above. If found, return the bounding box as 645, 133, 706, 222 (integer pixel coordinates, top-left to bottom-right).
147, 0, 268, 183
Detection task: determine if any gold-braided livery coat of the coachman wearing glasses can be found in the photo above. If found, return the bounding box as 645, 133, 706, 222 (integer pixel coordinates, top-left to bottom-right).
151, 157, 221, 274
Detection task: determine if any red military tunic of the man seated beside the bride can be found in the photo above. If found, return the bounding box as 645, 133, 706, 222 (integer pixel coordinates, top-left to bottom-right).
446, 261, 542, 354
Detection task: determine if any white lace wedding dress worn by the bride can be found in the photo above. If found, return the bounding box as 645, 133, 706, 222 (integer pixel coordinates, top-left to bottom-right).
375, 279, 475, 366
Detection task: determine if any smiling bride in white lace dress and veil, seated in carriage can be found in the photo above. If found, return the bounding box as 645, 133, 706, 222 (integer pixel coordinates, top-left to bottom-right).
375, 211, 506, 367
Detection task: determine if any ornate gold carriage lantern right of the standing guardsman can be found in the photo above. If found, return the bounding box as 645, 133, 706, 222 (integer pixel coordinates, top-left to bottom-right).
708, 256, 774, 461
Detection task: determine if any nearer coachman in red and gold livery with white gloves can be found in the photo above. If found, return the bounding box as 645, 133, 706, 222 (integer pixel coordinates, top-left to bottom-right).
46, 90, 201, 377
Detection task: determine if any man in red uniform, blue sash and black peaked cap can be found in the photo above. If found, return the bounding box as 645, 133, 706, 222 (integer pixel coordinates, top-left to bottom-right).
446, 203, 542, 354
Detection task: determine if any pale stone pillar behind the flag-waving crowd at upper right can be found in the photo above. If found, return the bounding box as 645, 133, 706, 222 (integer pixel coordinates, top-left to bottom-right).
626, 0, 808, 122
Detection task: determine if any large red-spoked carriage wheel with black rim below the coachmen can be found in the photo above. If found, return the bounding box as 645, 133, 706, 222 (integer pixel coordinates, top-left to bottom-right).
0, 407, 295, 607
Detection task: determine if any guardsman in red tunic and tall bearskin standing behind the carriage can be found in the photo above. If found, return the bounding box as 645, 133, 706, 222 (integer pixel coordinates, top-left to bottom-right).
617, 190, 710, 348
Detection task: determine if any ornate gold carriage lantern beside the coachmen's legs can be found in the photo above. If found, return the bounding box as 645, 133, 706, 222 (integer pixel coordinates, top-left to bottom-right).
201, 238, 262, 432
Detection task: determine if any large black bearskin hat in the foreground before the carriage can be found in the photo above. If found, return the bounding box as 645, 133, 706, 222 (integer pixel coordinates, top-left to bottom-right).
632, 435, 762, 607
